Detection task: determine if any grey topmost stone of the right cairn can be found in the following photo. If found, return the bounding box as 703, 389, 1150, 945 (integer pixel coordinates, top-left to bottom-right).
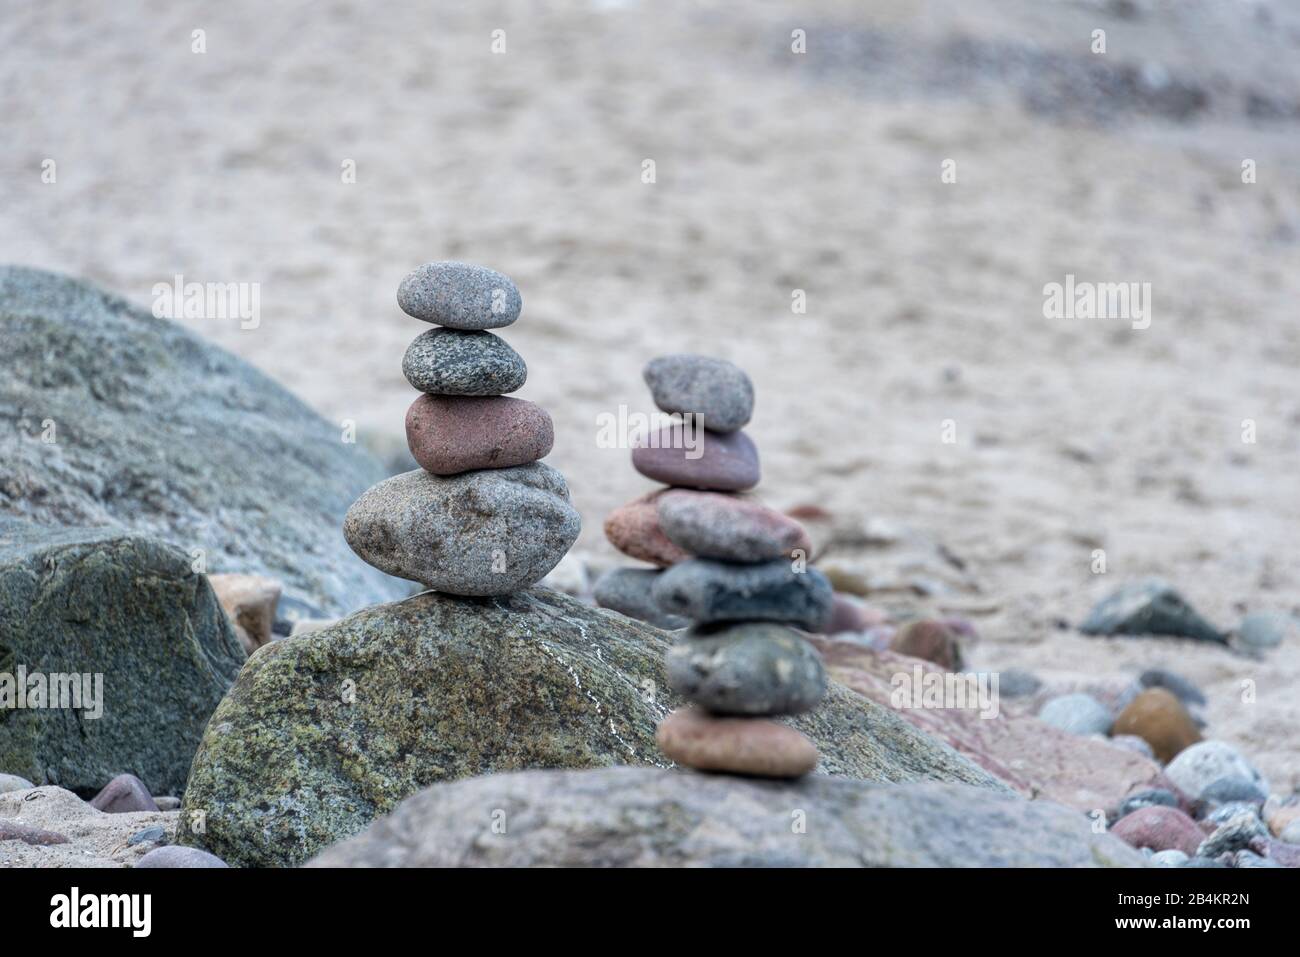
641, 352, 754, 432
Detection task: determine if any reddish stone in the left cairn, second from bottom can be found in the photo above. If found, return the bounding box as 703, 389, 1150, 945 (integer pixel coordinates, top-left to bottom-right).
407, 395, 555, 476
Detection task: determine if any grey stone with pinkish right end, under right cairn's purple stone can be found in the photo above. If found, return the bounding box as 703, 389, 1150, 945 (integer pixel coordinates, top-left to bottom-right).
658, 489, 813, 562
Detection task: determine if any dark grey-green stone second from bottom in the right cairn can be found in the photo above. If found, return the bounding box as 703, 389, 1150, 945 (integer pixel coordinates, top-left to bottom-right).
664, 622, 826, 715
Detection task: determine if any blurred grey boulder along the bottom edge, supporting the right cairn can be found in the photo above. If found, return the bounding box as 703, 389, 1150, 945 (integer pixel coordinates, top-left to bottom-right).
308, 767, 1145, 867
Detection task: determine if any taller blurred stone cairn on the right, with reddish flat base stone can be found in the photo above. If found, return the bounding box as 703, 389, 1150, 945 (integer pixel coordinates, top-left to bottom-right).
597, 355, 832, 778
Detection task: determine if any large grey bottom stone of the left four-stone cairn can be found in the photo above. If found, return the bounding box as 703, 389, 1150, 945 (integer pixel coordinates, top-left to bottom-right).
343, 462, 581, 596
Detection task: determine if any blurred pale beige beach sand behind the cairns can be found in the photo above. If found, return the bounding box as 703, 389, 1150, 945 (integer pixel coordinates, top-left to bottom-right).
0, 0, 1300, 792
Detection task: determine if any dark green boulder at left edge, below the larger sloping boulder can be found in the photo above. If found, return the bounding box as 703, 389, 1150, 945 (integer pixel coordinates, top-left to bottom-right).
0, 518, 244, 796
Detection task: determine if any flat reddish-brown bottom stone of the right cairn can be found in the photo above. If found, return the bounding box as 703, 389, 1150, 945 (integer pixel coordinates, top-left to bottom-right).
655, 707, 818, 778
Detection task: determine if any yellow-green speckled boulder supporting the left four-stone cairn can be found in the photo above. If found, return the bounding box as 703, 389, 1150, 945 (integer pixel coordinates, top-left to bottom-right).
182, 588, 1005, 865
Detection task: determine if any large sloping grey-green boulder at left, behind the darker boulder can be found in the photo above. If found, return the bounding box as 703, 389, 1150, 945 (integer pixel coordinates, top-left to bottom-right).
0, 267, 408, 616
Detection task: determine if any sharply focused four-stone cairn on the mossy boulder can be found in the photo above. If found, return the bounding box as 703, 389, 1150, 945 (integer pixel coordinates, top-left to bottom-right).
343, 263, 581, 596
